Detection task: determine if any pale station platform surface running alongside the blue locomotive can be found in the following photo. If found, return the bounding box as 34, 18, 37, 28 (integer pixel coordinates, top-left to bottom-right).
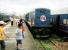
5, 22, 40, 50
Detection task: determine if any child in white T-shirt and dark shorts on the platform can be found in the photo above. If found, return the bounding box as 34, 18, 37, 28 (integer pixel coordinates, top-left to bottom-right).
16, 23, 23, 50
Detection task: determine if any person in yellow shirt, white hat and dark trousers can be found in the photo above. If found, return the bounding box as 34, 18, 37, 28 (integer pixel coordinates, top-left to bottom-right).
0, 21, 8, 50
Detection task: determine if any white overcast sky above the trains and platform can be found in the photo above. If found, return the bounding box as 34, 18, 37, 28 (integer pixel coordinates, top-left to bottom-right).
0, 0, 68, 14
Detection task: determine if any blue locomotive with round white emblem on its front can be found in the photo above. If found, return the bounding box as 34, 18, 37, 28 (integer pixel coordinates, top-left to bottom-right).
25, 8, 54, 37
